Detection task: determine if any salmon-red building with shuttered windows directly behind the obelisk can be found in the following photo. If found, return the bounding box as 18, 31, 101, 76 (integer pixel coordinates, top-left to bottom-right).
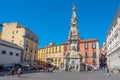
62, 39, 100, 69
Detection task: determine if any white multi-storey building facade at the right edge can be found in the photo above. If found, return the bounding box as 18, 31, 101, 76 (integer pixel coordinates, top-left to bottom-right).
106, 8, 120, 69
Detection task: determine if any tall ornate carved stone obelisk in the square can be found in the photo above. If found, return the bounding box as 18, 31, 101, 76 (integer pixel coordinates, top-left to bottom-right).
64, 5, 81, 71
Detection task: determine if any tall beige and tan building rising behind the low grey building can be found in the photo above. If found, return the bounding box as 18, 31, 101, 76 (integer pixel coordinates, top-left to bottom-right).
2, 22, 38, 64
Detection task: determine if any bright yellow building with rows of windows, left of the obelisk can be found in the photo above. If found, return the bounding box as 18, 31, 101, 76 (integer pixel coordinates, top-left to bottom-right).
38, 43, 63, 67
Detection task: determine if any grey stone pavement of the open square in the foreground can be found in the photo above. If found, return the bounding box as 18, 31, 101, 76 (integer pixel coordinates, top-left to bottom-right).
0, 71, 120, 80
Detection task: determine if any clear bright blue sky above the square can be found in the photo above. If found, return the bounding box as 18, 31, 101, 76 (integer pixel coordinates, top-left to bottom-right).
0, 0, 120, 48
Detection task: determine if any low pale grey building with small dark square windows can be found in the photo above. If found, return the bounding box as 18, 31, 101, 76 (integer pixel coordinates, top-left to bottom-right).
0, 39, 23, 65
